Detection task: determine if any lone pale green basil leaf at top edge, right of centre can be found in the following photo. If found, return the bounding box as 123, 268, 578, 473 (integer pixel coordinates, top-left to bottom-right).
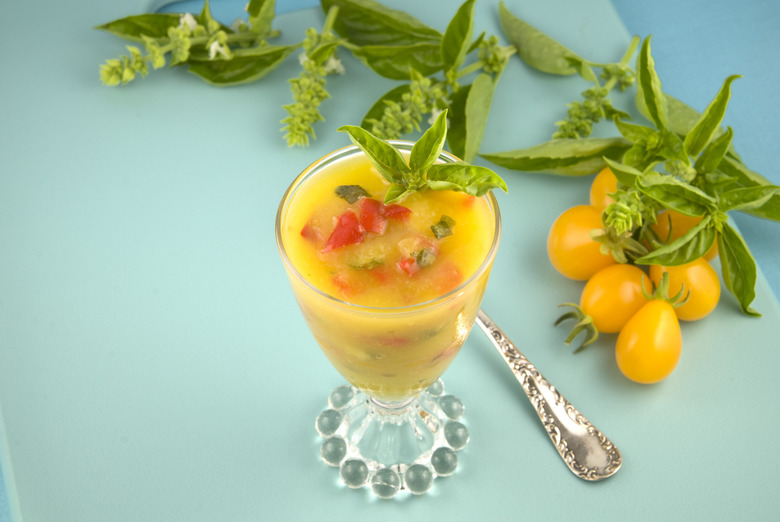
498, 2, 584, 75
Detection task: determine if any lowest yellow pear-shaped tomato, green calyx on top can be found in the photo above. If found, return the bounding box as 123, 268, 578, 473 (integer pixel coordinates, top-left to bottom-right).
615, 299, 682, 384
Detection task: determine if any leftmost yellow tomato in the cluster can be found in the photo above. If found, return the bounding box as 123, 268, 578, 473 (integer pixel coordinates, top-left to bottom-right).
547, 205, 616, 281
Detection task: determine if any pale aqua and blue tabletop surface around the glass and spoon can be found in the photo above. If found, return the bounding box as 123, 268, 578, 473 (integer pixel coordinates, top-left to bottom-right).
0, 0, 780, 522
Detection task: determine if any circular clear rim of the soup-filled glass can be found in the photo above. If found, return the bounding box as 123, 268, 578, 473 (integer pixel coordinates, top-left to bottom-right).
274, 140, 501, 313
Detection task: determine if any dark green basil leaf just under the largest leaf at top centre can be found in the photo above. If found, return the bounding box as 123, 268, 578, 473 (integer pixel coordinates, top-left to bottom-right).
352, 42, 444, 80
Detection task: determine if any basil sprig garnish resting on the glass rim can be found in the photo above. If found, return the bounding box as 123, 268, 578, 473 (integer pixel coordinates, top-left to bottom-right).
338, 110, 507, 204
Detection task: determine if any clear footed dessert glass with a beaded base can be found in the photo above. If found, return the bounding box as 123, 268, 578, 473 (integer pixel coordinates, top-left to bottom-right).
275, 141, 501, 498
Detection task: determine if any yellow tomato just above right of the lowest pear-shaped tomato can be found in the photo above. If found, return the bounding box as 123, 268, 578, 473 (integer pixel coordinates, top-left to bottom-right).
650, 257, 720, 321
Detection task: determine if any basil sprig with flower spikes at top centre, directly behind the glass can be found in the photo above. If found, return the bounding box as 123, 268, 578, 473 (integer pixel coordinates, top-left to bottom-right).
332, 0, 514, 161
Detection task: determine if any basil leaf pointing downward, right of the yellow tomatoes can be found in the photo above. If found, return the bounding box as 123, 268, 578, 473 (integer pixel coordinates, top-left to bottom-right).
718, 223, 761, 316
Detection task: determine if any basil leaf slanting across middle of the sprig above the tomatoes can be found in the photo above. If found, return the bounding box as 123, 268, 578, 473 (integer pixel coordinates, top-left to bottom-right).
636, 171, 717, 216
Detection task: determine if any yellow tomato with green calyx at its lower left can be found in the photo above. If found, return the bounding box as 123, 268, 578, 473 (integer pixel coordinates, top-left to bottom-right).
580, 263, 652, 333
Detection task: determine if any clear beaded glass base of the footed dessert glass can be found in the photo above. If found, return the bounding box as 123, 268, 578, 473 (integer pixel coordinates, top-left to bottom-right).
316, 380, 469, 498
